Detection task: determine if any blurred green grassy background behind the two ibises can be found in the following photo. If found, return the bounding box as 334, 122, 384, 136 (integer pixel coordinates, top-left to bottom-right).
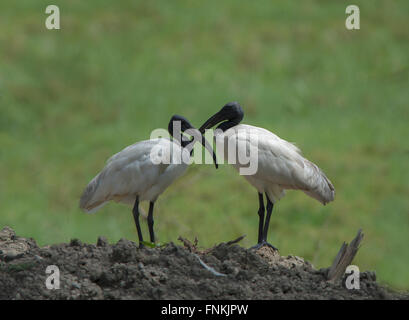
0, 0, 409, 290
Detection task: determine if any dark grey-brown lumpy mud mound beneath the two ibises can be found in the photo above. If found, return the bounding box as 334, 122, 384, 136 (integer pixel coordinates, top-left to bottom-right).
0, 227, 406, 299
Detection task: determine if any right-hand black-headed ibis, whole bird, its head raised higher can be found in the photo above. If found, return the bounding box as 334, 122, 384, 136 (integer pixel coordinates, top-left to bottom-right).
199, 102, 335, 249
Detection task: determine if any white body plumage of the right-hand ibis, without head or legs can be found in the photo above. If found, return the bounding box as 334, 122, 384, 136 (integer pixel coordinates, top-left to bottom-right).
216, 124, 335, 204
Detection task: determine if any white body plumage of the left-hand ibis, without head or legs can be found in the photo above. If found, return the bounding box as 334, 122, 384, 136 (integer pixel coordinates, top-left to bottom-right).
80, 138, 190, 213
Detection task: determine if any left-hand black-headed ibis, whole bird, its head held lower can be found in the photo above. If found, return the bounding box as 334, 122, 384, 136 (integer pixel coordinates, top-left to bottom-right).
80, 115, 217, 247
